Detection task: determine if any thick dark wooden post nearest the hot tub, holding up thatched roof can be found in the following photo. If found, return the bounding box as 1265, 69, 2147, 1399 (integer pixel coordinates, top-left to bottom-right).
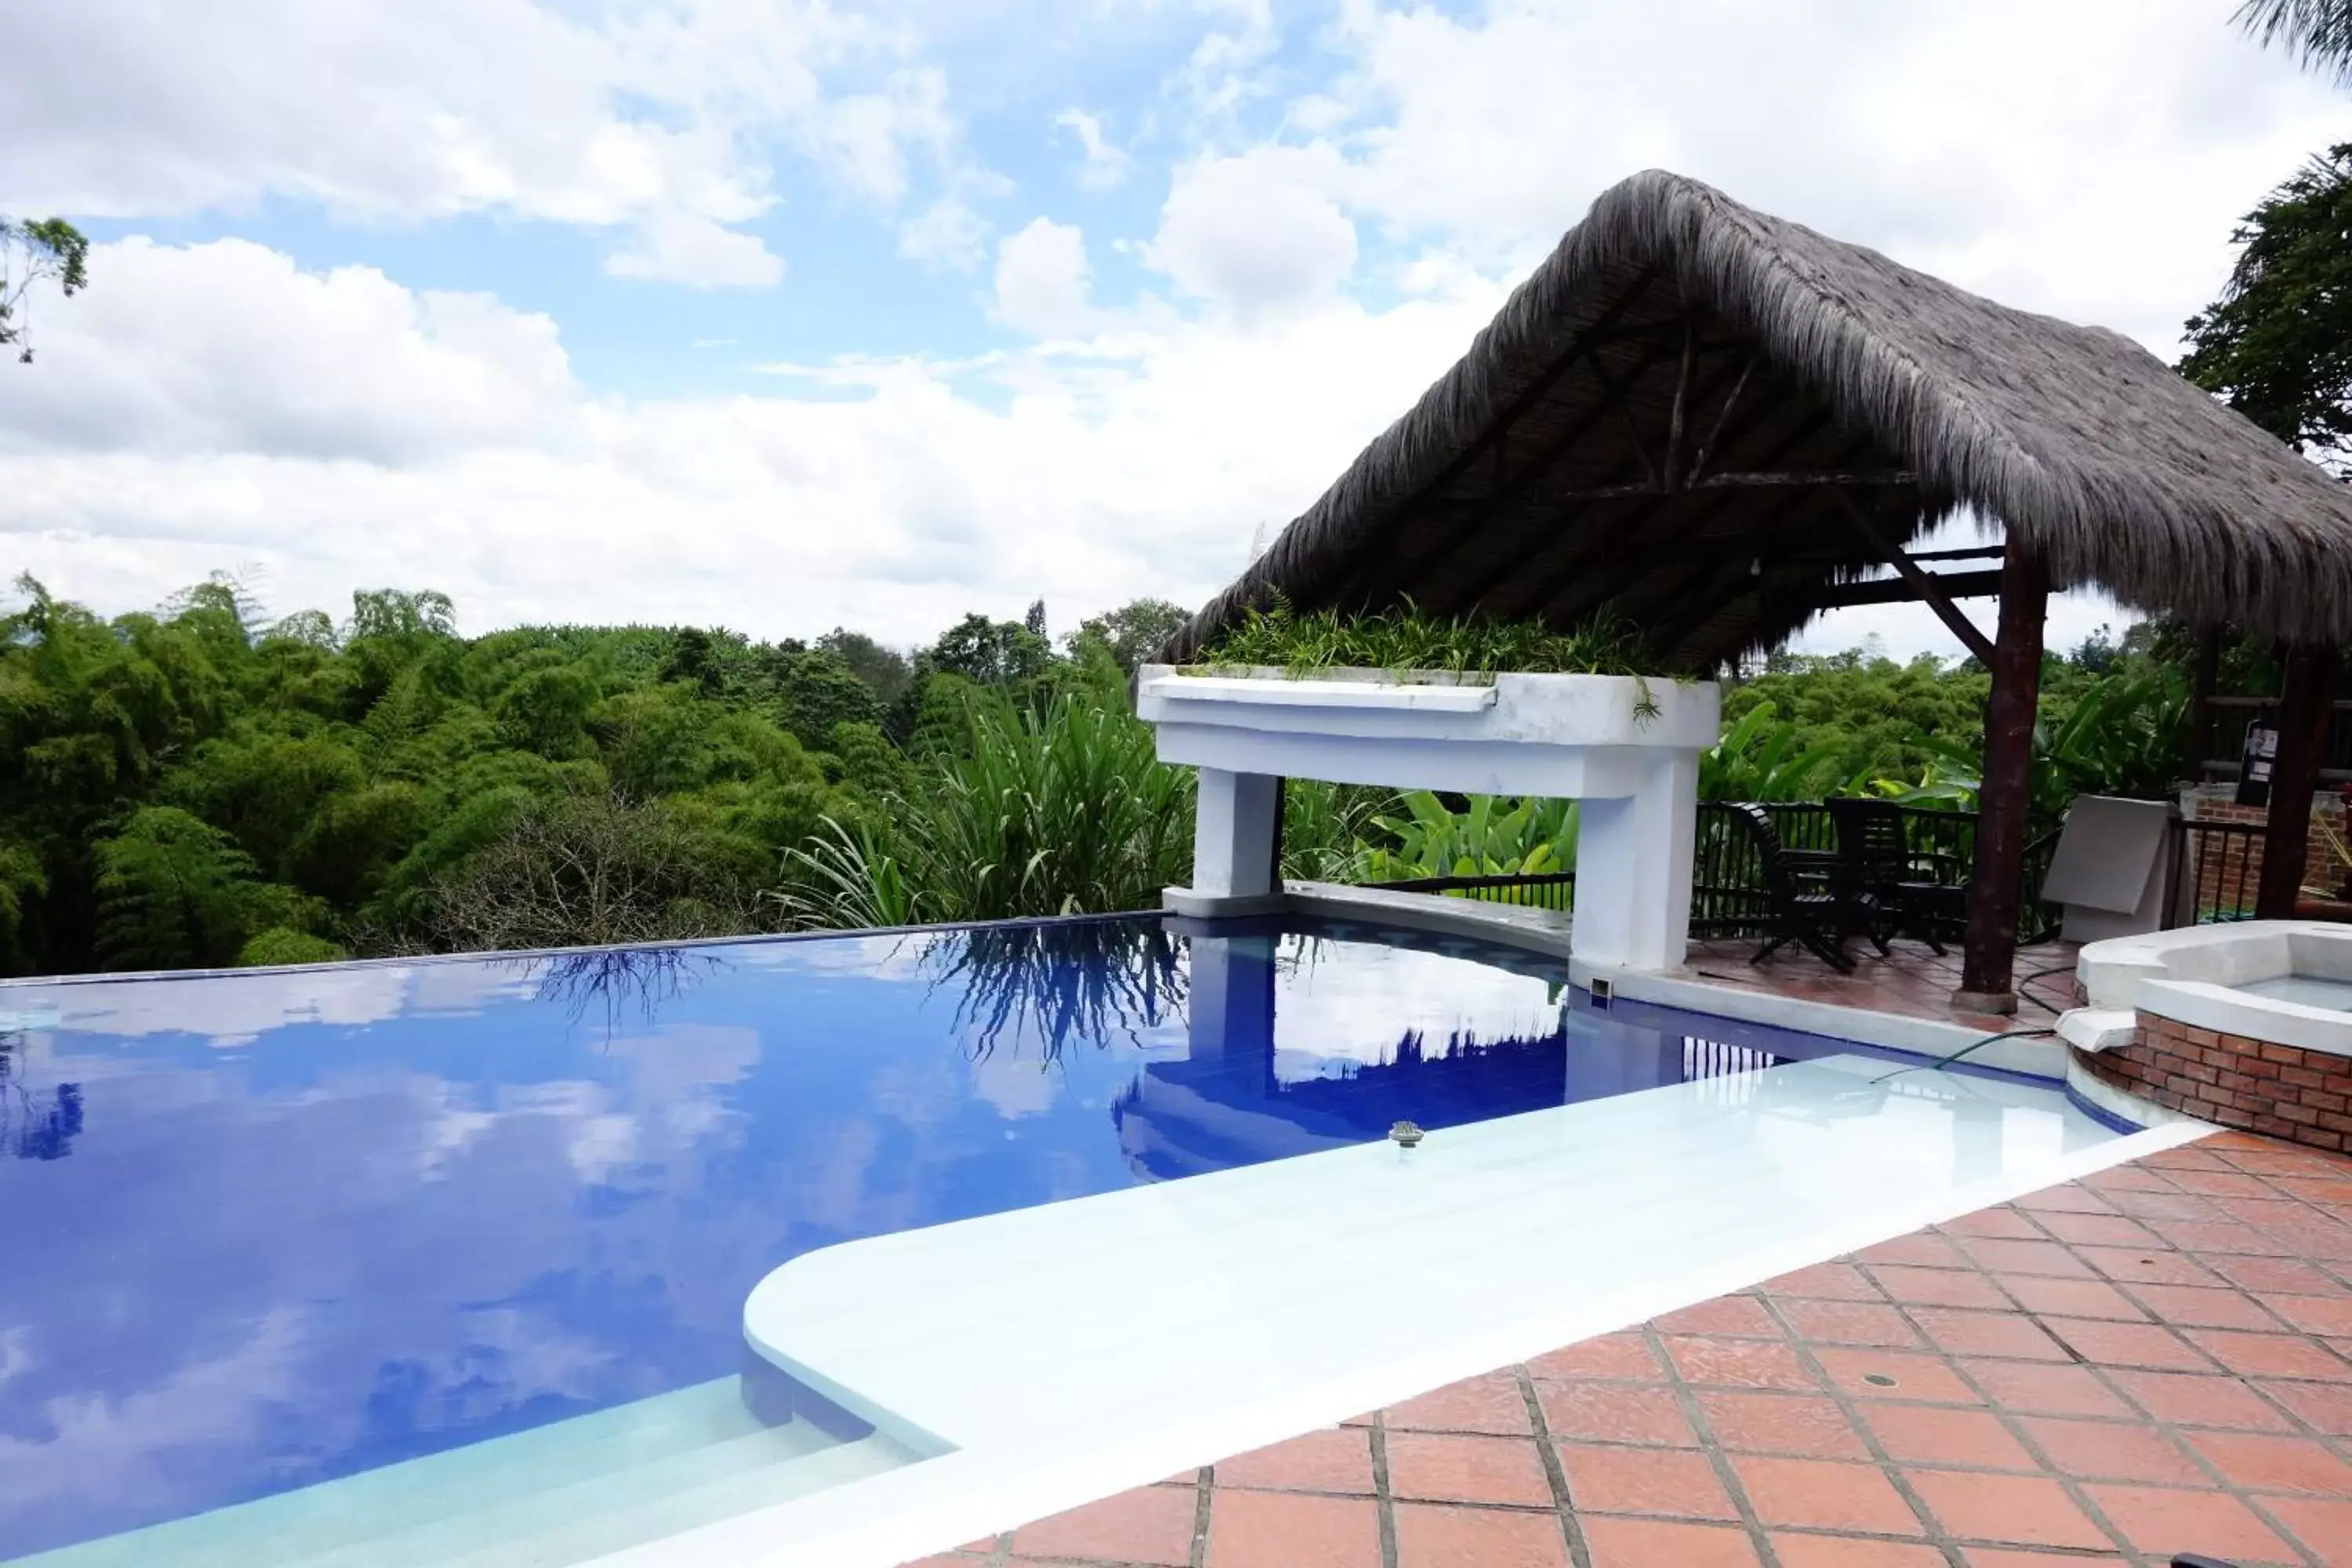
1952, 536, 2051, 1013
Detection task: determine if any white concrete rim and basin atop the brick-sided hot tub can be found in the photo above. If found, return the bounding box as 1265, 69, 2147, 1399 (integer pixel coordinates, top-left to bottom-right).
2058, 919, 2352, 1055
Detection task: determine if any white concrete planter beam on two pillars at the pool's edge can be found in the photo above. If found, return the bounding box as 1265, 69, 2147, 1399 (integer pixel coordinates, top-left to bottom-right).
1136, 666, 1722, 971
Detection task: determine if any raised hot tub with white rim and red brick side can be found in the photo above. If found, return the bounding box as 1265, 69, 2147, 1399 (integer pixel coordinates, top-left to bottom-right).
2058, 919, 2352, 1152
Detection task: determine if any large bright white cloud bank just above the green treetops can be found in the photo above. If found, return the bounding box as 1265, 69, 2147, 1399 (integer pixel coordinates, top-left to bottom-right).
0, 226, 1496, 642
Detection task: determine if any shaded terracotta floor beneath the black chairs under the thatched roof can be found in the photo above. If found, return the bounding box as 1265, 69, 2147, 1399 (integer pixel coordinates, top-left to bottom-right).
1682, 938, 2079, 1034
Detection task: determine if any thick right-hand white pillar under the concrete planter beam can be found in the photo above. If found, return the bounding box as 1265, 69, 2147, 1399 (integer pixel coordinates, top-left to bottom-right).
1569, 748, 1698, 971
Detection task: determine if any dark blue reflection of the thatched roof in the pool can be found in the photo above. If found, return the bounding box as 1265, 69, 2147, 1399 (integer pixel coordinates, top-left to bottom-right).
1110, 1029, 1566, 1180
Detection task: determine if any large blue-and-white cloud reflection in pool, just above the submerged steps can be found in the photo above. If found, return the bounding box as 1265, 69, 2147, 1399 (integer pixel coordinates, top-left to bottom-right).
0, 1029, 757, 1528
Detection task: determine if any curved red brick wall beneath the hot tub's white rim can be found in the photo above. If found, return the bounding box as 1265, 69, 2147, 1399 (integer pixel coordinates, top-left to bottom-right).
2077, 1013, 2352, 1152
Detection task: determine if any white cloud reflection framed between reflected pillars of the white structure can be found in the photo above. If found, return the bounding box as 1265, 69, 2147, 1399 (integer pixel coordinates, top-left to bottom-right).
1275, 935, 1559, 1062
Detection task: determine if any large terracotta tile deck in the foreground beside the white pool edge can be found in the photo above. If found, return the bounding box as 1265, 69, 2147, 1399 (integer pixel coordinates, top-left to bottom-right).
908, 1133, 2352, 1568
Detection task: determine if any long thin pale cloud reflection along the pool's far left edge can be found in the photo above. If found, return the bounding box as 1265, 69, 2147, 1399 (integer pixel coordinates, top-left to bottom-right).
9, 959, 532, 1046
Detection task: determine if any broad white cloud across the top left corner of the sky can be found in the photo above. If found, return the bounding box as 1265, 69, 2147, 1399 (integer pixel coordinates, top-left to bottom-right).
0, 0, 967, 287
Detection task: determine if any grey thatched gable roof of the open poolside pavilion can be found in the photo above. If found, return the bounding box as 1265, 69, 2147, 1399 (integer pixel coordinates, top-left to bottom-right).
1167, 169, 2352, 670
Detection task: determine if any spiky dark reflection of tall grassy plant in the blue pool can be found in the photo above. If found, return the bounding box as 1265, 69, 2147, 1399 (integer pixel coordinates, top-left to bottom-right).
922, 919, 1188, 1062
